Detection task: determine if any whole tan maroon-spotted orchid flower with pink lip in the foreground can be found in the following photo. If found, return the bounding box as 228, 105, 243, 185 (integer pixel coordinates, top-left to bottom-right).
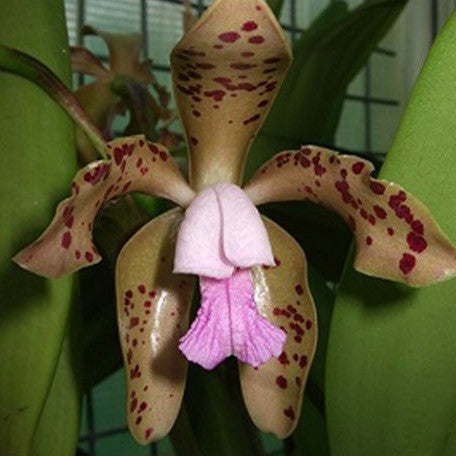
15, 0, 456, 443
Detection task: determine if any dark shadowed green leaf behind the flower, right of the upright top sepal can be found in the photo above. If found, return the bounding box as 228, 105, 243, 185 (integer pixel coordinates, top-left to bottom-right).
246, 0, 407, 176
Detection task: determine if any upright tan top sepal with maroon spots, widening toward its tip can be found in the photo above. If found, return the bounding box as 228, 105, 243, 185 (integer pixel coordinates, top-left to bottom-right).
171, 0, 291, 190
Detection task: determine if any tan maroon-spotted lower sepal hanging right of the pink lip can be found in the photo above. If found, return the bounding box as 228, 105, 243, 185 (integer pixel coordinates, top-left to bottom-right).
239, 217, 317, 438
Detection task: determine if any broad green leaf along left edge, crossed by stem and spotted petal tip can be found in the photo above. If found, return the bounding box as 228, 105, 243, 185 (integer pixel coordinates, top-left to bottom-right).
0, 0, 75, 456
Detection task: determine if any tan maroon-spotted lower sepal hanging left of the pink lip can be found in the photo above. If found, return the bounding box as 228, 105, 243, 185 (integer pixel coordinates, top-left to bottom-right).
116, 209, 195, 444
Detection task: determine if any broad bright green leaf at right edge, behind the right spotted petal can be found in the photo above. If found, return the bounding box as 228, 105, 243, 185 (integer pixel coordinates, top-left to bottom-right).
326, 10, 456, 456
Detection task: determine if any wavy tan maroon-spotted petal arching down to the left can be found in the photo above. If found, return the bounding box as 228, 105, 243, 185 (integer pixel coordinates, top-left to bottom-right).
14, 136, 194, 277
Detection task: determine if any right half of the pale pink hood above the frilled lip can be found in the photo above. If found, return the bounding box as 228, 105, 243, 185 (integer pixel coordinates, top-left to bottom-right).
214, 183, 275, 269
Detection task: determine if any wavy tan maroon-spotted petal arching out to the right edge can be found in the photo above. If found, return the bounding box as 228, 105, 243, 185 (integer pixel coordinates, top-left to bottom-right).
245, 146, 456, 286
